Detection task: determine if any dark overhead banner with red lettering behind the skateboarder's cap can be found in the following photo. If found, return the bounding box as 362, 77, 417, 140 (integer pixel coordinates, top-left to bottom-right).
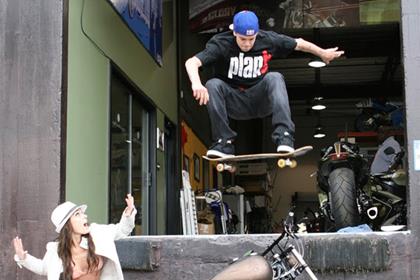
190, 0, 374, 32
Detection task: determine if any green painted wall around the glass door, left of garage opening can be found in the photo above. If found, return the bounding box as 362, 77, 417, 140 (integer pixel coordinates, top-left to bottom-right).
66, 0, 178, 225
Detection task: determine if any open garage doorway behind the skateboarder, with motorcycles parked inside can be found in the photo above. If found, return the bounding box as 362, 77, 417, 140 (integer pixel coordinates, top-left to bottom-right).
181, 0, 407, 234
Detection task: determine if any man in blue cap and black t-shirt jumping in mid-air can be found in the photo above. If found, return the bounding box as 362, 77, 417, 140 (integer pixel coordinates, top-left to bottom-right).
185, 11, 344, 158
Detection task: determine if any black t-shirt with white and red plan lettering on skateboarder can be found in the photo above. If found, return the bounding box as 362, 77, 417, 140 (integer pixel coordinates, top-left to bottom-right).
195, 30, 296, 87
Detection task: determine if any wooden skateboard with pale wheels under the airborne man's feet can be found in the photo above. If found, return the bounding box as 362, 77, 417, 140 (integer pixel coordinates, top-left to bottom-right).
203, 146, 313, 173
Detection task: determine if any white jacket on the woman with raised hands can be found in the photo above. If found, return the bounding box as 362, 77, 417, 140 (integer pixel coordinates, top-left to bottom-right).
15, 209, 137, 280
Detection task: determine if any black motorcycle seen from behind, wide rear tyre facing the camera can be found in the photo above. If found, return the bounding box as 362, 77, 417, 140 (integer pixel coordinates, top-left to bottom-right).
317, 142, 369, 229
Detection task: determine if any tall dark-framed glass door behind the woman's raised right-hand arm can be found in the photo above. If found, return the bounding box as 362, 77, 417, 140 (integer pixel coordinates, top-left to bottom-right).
110, 71, 151, 235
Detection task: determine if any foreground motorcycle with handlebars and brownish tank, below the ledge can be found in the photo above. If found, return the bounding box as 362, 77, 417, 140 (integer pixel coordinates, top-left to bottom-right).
211, 212, 318, 280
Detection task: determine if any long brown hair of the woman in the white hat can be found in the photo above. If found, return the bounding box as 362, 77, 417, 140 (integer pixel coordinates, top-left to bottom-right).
58, 219, 99, 280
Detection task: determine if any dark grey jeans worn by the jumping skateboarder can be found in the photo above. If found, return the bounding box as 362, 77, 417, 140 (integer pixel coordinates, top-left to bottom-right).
206, 72, 295, 142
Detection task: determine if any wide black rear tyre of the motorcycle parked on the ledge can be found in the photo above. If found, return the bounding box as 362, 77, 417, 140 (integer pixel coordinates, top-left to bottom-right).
328, 168, 360, 230
